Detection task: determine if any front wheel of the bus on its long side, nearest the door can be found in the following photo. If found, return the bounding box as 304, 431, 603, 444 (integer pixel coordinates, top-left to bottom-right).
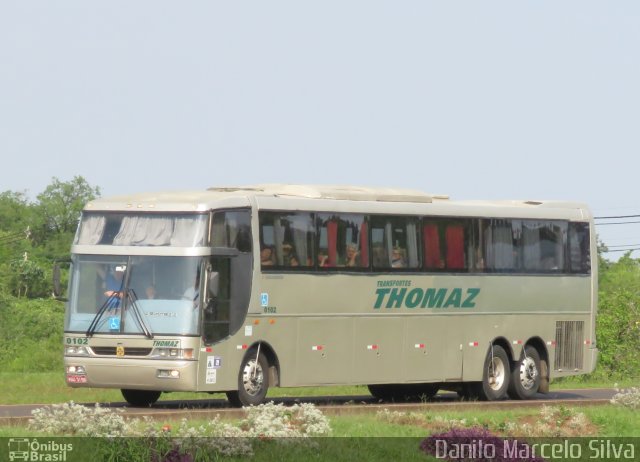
227, 350, 269, 407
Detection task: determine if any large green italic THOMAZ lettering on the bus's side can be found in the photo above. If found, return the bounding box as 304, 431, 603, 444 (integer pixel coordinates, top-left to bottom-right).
373, 287, 480, 310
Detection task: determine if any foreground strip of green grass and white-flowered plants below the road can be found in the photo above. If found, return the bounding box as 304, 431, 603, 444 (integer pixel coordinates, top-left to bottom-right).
0, 389, 640, 461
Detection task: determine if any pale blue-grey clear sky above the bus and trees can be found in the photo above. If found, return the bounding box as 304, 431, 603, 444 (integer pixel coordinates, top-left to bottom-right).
0, 0, 640, 259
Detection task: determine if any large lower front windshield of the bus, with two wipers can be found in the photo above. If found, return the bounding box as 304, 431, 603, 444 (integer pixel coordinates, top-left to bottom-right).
65, 255, 202, 337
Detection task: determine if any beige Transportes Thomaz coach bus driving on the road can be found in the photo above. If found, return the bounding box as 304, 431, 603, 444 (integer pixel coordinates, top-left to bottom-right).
64, 184, 598, 406
